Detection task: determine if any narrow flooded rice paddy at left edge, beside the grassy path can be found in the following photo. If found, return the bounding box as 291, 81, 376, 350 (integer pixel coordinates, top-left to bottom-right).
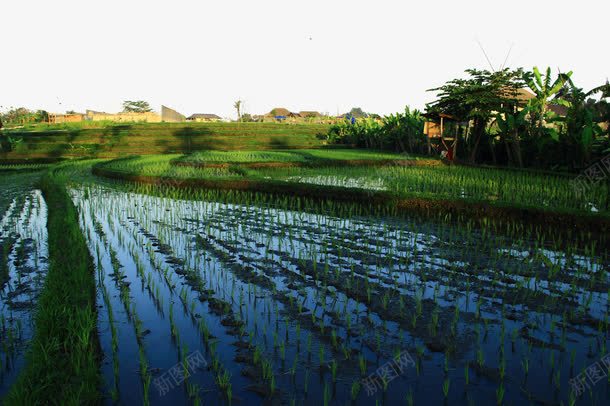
0, 175, 48, 394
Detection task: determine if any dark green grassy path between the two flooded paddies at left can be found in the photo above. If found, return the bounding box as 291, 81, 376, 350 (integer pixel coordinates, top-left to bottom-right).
4, 175, 101, 405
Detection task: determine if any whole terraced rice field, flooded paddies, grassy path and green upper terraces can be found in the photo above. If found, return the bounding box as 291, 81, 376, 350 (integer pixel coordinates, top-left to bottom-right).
0, 157, 610, 405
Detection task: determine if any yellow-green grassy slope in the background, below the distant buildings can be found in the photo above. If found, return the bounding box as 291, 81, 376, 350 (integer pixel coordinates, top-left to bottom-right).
0, 123, 328, 162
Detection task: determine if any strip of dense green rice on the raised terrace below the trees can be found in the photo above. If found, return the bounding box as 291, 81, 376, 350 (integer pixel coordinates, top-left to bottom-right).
257, 165, 610, 215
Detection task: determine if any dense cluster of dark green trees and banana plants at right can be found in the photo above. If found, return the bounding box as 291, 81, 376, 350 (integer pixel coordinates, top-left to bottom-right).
327, 68, 610, 170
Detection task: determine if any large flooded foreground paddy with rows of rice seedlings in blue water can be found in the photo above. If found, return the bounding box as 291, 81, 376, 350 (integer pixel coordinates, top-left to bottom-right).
64, 185, 610, 405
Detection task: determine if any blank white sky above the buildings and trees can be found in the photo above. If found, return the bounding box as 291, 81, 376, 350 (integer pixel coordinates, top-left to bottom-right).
0, 0, 610, 117
